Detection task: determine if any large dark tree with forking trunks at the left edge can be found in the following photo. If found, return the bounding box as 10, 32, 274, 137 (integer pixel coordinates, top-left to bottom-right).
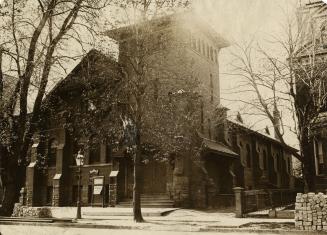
0, 0, 109, 215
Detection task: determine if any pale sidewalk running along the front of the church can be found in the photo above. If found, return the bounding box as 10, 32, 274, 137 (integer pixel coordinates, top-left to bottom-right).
3, 207, 304, 234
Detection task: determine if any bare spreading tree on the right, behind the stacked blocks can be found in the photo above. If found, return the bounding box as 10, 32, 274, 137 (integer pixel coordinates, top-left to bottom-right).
233, 2, 326, 191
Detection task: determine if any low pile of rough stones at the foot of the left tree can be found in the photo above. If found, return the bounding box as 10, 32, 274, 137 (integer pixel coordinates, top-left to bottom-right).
12, 203, 52, 218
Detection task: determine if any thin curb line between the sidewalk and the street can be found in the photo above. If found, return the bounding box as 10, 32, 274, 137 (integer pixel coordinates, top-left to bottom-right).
0, 221, 327, 235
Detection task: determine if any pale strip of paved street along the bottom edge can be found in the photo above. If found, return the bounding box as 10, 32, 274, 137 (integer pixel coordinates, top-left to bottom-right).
0, 225, 294, 235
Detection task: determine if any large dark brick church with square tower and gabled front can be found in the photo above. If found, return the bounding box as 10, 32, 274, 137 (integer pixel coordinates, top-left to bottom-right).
26, 12, 294, 208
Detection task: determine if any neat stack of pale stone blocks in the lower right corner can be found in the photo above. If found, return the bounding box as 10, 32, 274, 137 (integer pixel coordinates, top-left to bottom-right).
295, 193, 327, 231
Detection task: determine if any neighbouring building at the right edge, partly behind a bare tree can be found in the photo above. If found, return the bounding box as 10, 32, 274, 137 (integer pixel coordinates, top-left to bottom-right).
297, 1, 327, 191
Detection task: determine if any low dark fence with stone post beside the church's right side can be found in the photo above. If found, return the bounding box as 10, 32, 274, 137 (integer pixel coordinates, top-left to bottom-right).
234, 188, 296, 217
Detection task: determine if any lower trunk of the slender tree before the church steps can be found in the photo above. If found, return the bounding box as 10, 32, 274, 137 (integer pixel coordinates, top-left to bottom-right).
133, 149, 144, 222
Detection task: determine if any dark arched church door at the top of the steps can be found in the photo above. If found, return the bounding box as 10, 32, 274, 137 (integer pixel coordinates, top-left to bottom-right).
142, 161, 167, 194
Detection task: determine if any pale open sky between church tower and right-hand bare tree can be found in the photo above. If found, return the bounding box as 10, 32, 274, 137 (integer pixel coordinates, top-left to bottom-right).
194, 0, 313, 146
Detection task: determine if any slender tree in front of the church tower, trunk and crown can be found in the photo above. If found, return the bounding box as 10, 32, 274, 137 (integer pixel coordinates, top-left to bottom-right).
104, 0, 199, 222
